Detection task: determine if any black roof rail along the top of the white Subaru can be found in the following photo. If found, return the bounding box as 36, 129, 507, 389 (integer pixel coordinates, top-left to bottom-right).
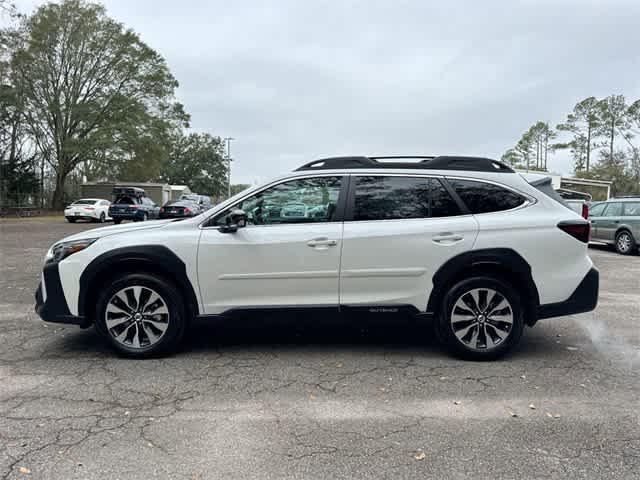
295, 156, 514, 173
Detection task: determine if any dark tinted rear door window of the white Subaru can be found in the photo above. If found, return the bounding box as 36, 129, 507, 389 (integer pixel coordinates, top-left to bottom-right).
353, 176, 460, 220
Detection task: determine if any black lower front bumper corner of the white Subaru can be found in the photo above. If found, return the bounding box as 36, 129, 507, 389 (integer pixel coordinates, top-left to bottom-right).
35, 263, 91, 328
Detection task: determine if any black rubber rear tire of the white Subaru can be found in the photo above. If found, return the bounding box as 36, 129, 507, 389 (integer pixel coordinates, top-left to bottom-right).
436, 276, 524, 360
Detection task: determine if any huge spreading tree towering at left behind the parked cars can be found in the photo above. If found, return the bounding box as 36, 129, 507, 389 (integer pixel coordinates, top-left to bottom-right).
11, 0, 188, 208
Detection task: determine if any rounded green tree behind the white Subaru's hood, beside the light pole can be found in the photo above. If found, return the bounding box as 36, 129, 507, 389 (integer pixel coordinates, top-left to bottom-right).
161, 133, 227, 197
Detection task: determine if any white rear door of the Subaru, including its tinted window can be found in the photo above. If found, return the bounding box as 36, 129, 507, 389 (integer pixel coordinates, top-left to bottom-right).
340, 174, 478, 311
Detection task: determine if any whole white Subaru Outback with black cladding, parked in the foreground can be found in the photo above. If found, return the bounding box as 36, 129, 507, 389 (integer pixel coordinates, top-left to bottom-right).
36, 156, 598, 359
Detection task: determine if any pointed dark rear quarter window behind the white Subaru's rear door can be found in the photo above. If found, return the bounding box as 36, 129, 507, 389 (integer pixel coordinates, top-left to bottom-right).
449, 179, 524, 213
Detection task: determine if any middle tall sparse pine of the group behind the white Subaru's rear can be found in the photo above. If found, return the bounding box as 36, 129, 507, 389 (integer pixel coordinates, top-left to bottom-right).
554, 97, 601, 172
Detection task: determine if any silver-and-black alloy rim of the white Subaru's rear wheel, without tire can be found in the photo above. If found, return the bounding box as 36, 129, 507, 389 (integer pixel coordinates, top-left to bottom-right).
450, 288, 513, 352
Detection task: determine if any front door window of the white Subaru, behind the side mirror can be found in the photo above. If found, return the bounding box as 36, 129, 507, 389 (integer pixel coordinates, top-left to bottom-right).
214, 177, 342, 226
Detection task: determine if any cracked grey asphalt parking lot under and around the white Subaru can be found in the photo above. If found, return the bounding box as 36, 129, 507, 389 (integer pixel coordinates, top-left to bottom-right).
0, 220, 640, 480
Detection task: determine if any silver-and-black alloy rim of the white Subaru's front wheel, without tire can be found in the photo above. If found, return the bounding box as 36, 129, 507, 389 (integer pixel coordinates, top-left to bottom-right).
105, 285, 170, 349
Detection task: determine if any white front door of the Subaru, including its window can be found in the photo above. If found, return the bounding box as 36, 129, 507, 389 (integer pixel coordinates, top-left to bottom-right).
198, 175, 345, 314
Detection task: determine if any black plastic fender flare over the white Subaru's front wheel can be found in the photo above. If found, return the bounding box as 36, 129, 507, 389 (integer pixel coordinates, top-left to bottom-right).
78, 245, 200, 317
